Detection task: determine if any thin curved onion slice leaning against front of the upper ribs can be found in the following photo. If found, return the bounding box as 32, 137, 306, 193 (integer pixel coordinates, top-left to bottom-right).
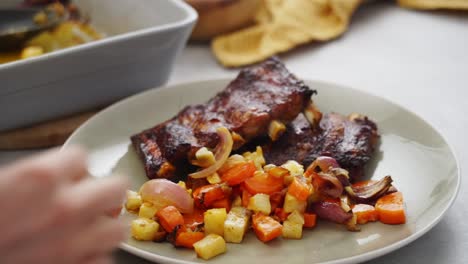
189, 127, 234, 179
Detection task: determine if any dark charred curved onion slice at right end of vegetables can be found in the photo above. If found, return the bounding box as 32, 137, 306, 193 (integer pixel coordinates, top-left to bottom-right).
345, 176, 393, 203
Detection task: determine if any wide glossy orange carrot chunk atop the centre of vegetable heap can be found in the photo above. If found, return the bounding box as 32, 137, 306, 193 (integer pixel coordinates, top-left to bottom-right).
242, 173, 283, 194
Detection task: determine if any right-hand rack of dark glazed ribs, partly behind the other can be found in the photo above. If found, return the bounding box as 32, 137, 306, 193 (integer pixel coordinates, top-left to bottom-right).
263, 113, 379, 180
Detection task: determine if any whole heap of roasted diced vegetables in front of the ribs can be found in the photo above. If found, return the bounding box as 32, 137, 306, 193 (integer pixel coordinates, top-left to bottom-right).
125, 129, 406, 259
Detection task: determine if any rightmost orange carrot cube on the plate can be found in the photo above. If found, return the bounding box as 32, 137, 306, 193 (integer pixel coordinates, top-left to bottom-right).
375, 192, 406, 225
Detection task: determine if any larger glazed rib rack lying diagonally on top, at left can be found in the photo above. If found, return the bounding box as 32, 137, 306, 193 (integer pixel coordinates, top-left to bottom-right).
131, 58, 316, 181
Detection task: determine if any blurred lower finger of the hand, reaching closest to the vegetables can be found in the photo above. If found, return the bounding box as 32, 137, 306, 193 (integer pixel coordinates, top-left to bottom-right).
0, 174, 128, 251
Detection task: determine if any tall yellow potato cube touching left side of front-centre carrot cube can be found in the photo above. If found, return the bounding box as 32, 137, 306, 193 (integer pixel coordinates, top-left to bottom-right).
224, 207, 250, 243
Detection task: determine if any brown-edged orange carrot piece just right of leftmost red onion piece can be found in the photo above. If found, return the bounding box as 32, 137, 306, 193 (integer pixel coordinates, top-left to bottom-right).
193, 184, 231, 209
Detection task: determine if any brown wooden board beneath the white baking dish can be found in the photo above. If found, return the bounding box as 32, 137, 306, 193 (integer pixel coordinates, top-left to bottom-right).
0, 111, 97, 150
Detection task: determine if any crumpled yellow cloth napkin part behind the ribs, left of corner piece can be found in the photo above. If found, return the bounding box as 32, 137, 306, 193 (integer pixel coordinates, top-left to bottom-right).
212, 0, 362, 67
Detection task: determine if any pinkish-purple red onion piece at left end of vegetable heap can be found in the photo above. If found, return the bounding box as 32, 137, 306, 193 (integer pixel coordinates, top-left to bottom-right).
140, 179, 193, 214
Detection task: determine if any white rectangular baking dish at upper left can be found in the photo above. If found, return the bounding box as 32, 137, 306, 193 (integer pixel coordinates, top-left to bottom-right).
0, 0, 197, 131
